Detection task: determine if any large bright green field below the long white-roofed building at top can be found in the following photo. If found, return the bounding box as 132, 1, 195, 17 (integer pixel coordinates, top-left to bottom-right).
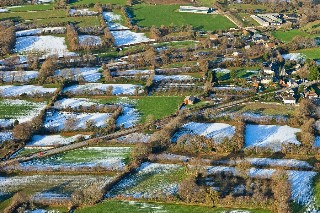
133, 4, 235, 31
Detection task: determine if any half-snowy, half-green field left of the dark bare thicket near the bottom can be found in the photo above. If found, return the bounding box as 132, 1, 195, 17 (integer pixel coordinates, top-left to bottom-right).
106, 162, 181, 199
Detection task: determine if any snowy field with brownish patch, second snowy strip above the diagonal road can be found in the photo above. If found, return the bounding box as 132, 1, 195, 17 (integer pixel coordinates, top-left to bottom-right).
44, 112, 111, 131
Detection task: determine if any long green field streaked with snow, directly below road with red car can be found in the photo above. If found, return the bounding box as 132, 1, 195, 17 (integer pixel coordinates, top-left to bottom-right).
20, 147, 132, 171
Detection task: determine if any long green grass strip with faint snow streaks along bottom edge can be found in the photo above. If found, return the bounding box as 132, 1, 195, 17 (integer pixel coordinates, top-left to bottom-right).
75, 200, 270, 213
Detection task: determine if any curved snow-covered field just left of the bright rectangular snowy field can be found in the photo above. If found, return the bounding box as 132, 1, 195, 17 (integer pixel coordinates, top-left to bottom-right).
172, 122, 235, 142
